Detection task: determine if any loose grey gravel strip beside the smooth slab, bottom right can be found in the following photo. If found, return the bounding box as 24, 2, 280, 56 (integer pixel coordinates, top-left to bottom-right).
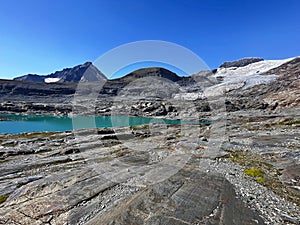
199, 159, 300, 224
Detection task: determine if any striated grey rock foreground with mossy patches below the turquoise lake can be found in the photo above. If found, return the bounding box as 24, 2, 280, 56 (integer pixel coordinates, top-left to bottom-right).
0, 108, 300, 225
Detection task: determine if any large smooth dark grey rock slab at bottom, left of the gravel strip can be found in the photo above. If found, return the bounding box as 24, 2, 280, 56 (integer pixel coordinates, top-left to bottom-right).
87, 168, 264, 225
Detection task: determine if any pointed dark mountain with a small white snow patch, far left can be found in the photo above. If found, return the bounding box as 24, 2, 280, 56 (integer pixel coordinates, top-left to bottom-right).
14, 62, 106, 83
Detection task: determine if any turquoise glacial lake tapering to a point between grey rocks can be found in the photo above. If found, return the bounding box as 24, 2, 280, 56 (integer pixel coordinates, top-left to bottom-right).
0, 115, 202, 134
